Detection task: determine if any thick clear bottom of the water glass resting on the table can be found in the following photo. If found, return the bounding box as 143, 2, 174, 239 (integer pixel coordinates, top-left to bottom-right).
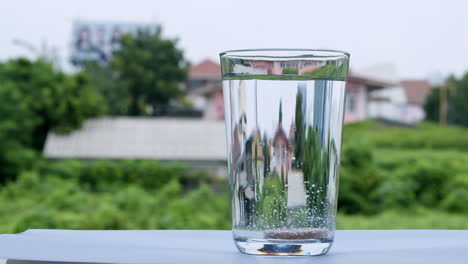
234, 238, 333, 256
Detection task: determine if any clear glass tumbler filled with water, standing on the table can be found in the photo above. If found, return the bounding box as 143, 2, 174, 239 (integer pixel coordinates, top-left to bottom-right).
220, 49, 349, 255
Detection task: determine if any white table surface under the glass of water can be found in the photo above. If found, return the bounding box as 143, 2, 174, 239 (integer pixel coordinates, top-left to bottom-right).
0, 230, 468, 264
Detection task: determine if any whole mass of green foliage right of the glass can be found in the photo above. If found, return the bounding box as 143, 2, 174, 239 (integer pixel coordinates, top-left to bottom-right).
339, 122, 468, 214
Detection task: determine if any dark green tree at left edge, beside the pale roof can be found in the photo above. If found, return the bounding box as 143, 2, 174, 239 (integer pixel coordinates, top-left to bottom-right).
0, 58, 104, 181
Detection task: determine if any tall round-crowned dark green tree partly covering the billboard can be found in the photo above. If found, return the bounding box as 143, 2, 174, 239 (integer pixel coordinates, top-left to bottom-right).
113, 27, 188, 115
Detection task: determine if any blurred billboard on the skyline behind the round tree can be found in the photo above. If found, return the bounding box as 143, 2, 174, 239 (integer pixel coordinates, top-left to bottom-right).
71, 21, 157, 66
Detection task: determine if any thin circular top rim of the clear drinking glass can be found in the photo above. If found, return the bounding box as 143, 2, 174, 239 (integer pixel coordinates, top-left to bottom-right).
219, 48, 350, 58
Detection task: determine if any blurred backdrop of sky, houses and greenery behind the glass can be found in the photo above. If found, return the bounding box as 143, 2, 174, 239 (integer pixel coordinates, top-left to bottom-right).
0, 0, 468, 233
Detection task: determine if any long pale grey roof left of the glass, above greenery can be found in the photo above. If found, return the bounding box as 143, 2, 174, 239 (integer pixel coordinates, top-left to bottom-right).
44, 117, 226, 161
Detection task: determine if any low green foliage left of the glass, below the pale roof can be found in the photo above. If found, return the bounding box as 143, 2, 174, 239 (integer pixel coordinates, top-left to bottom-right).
0, 160, 231, 233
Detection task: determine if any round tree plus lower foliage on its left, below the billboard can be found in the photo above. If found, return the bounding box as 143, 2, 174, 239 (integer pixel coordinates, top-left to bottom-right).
78, 27, 188, 116
